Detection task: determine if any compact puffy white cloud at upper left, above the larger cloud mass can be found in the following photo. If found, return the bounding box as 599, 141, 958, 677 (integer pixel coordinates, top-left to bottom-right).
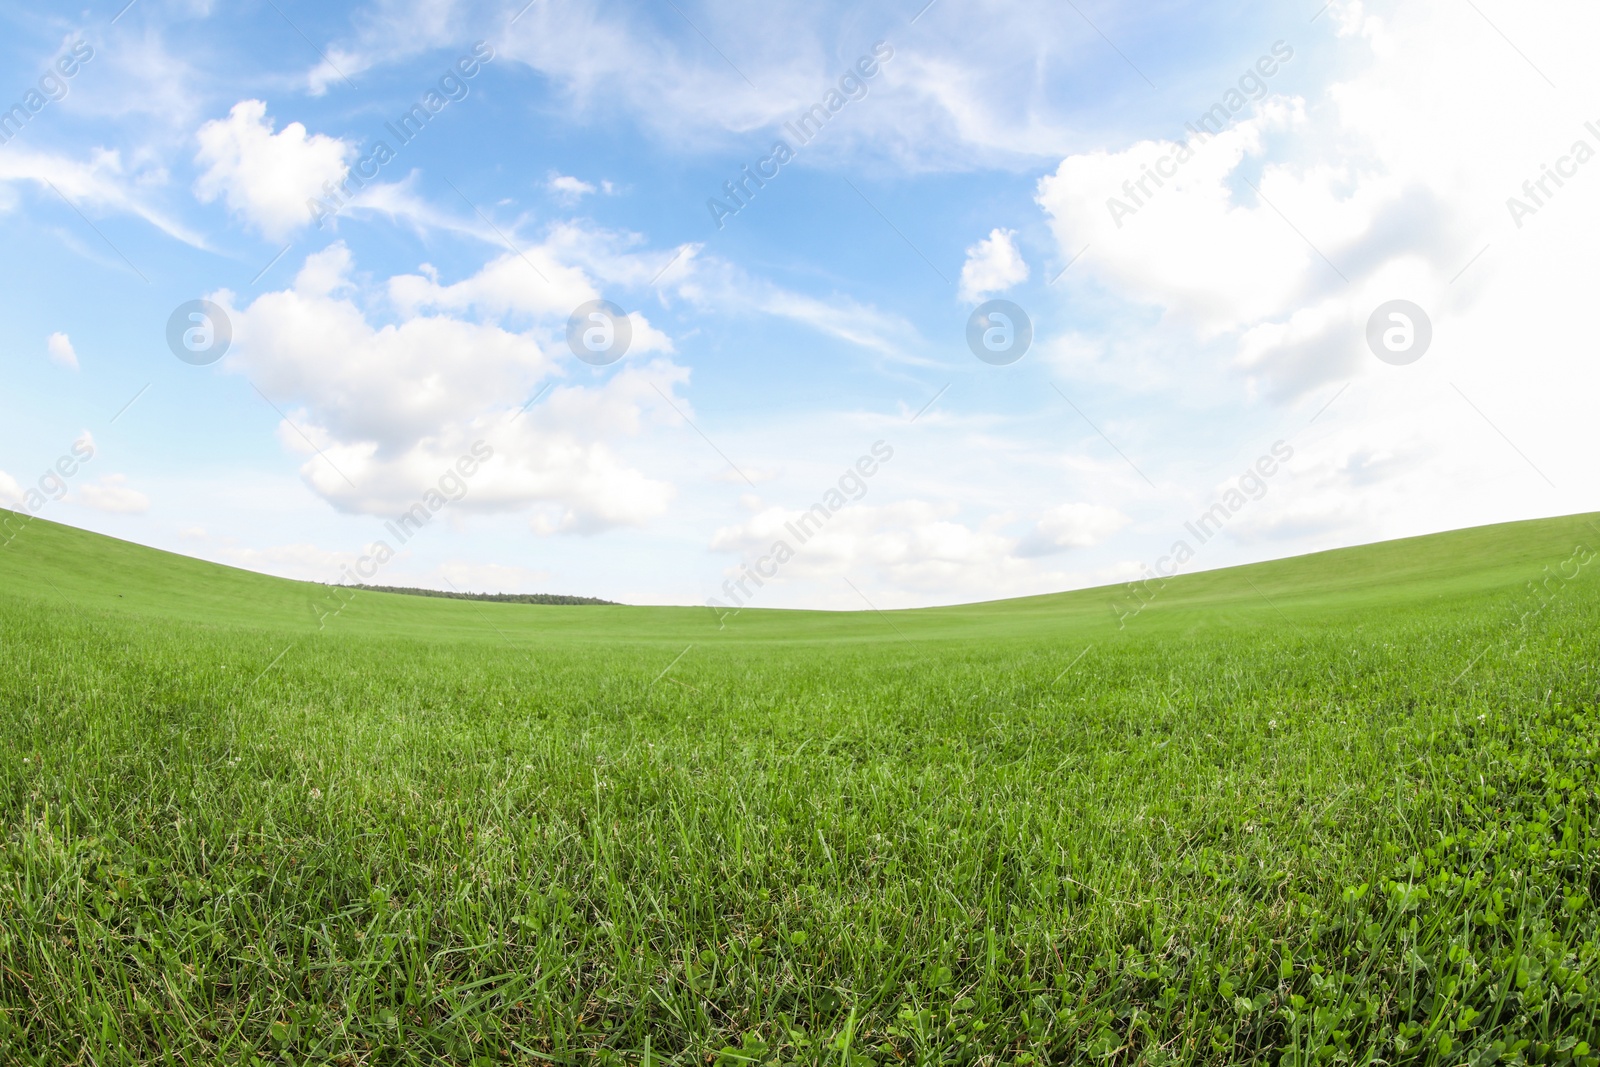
195, 99, 355, 240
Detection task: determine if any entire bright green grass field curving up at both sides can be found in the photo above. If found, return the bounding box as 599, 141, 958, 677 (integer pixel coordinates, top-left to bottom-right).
0, 517, 1600, 1065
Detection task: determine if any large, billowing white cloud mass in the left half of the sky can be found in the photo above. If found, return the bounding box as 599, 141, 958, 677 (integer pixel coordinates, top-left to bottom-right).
219, 243, 688, 534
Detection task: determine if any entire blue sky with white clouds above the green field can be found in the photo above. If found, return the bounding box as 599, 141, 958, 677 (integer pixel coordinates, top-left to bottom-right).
0, 0, 1600, 608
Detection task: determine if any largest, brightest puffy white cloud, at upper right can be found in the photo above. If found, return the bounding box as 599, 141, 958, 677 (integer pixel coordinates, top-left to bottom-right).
1037, 0, 1597, 400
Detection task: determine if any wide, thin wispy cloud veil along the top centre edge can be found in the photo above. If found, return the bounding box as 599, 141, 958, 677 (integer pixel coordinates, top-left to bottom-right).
309, 0, 1130, 171
